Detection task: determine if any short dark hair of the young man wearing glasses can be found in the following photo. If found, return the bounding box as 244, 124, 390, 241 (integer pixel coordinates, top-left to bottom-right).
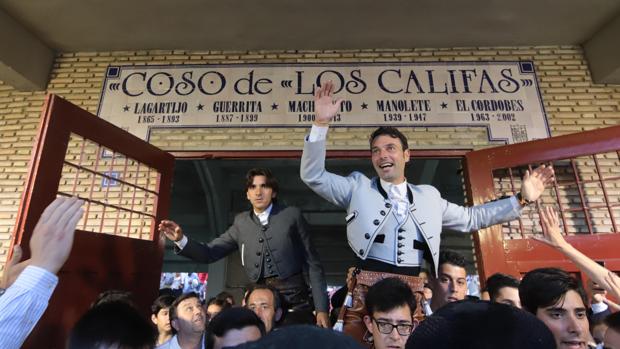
366, 278, 416, 316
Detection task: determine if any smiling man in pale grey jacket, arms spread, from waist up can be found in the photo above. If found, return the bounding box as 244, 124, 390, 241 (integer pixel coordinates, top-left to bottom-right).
300, 81, 553, 275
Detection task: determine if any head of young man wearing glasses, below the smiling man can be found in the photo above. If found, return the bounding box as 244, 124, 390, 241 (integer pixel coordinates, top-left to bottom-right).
364, 278, 416, 349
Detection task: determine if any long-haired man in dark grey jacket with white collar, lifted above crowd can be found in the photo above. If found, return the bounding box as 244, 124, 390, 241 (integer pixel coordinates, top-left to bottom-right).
159, 169, 329, 327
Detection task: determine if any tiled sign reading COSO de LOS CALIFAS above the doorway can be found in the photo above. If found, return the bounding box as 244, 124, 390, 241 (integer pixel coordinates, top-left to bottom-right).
97, 61, 550, 143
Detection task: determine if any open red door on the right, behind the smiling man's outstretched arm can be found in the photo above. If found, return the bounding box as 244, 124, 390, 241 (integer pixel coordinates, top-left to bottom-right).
466, 126, 620, 286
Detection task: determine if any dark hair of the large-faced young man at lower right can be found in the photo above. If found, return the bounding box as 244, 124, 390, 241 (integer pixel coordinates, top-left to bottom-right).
519, 268, 588, 314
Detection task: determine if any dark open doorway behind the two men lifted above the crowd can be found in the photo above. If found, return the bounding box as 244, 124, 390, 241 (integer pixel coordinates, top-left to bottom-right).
164, 157, 476, 296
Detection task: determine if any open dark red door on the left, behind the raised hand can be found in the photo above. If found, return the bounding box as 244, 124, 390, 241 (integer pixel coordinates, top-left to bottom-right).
12, 95, 174, 348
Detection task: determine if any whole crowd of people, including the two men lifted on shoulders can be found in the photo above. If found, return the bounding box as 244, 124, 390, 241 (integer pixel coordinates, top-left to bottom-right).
0, 82, 620, 349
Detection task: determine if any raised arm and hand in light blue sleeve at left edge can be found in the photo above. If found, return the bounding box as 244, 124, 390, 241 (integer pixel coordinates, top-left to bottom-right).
0, 197, 83, 349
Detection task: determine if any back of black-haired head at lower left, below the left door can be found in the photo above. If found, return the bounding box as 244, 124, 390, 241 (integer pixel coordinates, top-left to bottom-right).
67, 301, 157, 349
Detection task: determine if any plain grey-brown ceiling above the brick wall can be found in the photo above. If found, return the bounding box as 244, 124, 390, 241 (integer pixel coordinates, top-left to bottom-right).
0, 0, 620, 89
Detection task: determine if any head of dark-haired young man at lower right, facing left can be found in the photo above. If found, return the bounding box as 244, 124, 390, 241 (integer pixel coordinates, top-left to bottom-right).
519, 268, 590, 349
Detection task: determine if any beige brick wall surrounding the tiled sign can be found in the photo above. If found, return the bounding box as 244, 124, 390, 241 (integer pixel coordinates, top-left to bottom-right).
0, 46, 620, 273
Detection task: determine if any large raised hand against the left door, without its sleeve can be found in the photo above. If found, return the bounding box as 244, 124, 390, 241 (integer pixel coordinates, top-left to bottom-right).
30, 197, 84, 274
